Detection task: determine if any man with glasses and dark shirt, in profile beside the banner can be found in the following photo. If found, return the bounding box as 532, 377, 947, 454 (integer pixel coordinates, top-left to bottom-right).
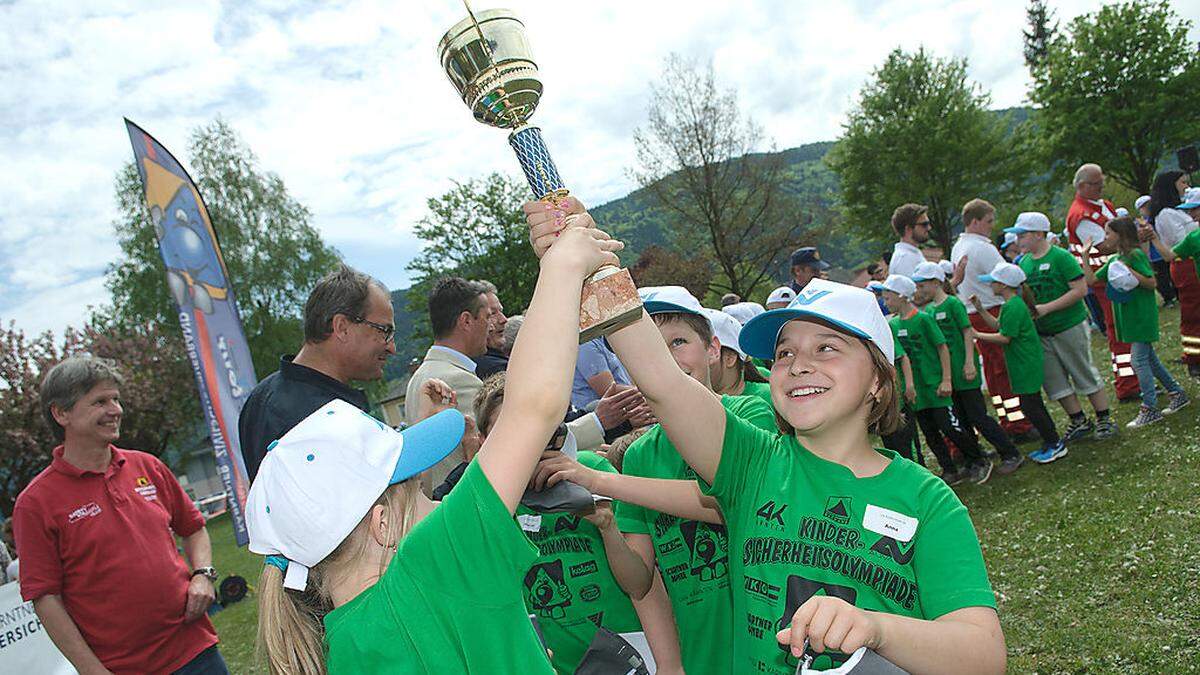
238, 264, 396, 480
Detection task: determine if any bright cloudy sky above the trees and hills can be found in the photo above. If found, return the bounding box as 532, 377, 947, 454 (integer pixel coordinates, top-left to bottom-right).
0, 0, 1200, 331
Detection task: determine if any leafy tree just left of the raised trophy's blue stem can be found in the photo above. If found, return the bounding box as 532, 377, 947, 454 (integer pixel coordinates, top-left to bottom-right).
408, 173, 539, 340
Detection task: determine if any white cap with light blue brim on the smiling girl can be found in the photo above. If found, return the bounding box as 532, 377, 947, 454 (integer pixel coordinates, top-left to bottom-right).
739, 279, 892, 363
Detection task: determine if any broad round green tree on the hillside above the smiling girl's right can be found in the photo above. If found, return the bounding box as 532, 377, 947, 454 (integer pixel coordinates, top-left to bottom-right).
826, 48, 1030, 249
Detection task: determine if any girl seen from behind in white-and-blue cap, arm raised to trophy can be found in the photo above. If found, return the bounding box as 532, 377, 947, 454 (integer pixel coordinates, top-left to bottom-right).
246, 223, 622, 674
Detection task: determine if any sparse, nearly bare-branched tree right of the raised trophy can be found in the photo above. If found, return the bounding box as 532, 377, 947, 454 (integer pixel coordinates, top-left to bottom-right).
631, 54, 804, 298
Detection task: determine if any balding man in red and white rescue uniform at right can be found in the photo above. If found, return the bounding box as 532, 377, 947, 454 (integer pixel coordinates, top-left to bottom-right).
1067, 163, 1141, 401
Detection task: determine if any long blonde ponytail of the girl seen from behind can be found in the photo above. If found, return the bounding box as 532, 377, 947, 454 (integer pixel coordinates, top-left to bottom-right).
257, 563, 329, 675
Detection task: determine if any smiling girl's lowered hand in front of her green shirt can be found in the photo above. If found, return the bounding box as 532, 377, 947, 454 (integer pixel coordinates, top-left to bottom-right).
775, 596, 882, 658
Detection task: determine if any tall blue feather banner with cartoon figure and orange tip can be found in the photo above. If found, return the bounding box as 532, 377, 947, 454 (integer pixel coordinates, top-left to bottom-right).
125, 120, 257, 545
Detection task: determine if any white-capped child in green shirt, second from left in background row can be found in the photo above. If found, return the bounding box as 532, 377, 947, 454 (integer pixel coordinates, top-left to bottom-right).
912, 257, 1025, 474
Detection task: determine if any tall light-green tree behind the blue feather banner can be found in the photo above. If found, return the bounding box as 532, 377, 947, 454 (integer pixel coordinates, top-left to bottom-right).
106, 119, 340, 374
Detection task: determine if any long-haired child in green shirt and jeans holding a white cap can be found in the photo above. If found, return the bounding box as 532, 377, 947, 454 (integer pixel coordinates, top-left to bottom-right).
1084, 216, 1189, 429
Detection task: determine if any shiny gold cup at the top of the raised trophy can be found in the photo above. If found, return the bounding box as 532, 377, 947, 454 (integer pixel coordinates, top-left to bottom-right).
438, 10, 541, 129
